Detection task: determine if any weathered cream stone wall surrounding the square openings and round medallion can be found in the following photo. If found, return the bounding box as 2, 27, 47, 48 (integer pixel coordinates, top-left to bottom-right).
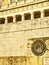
0, 0, 49, 65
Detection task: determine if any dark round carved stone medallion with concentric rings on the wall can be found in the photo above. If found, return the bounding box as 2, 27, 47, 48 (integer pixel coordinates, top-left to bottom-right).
31, 40, 46, 56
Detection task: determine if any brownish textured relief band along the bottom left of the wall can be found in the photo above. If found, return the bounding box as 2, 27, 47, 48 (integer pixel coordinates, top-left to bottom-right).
0, 56, 27, 65
